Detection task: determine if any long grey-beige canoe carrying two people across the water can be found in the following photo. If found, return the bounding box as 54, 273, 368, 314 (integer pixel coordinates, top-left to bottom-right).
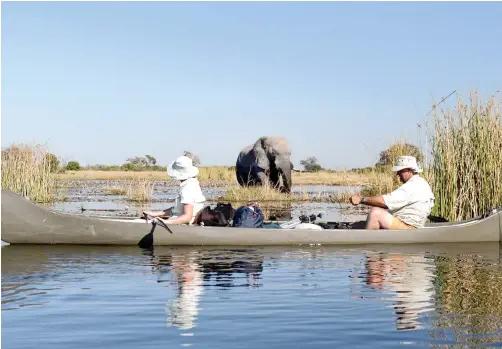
2, 190, 502, 246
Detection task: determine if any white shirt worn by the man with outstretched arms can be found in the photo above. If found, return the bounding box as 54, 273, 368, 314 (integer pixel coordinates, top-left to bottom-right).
383, 175, 434, 228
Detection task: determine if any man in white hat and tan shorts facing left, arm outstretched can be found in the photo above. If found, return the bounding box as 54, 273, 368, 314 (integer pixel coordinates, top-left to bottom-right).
350, 156, 434, 229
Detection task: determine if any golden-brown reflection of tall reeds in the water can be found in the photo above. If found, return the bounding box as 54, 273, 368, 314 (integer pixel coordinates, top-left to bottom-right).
431, 250, 502, 348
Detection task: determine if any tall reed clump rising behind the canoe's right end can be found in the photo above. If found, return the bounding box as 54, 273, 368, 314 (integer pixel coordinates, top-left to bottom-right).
426, 92, 502, 220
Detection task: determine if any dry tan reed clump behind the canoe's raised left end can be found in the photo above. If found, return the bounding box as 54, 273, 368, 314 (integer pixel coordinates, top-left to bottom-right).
2, 144, 55, 202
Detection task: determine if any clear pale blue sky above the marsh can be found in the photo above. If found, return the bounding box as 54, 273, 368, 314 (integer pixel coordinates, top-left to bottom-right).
1, 2, 502, 169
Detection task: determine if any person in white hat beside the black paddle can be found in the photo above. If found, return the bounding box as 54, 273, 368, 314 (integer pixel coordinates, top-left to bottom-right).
143, 156, 206, 224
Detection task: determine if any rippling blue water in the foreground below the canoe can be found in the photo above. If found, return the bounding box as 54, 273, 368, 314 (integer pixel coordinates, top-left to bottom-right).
1, 243, 502, 349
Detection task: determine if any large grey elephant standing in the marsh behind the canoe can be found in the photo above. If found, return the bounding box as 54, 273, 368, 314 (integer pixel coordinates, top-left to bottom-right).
235, 136, 293, 193
